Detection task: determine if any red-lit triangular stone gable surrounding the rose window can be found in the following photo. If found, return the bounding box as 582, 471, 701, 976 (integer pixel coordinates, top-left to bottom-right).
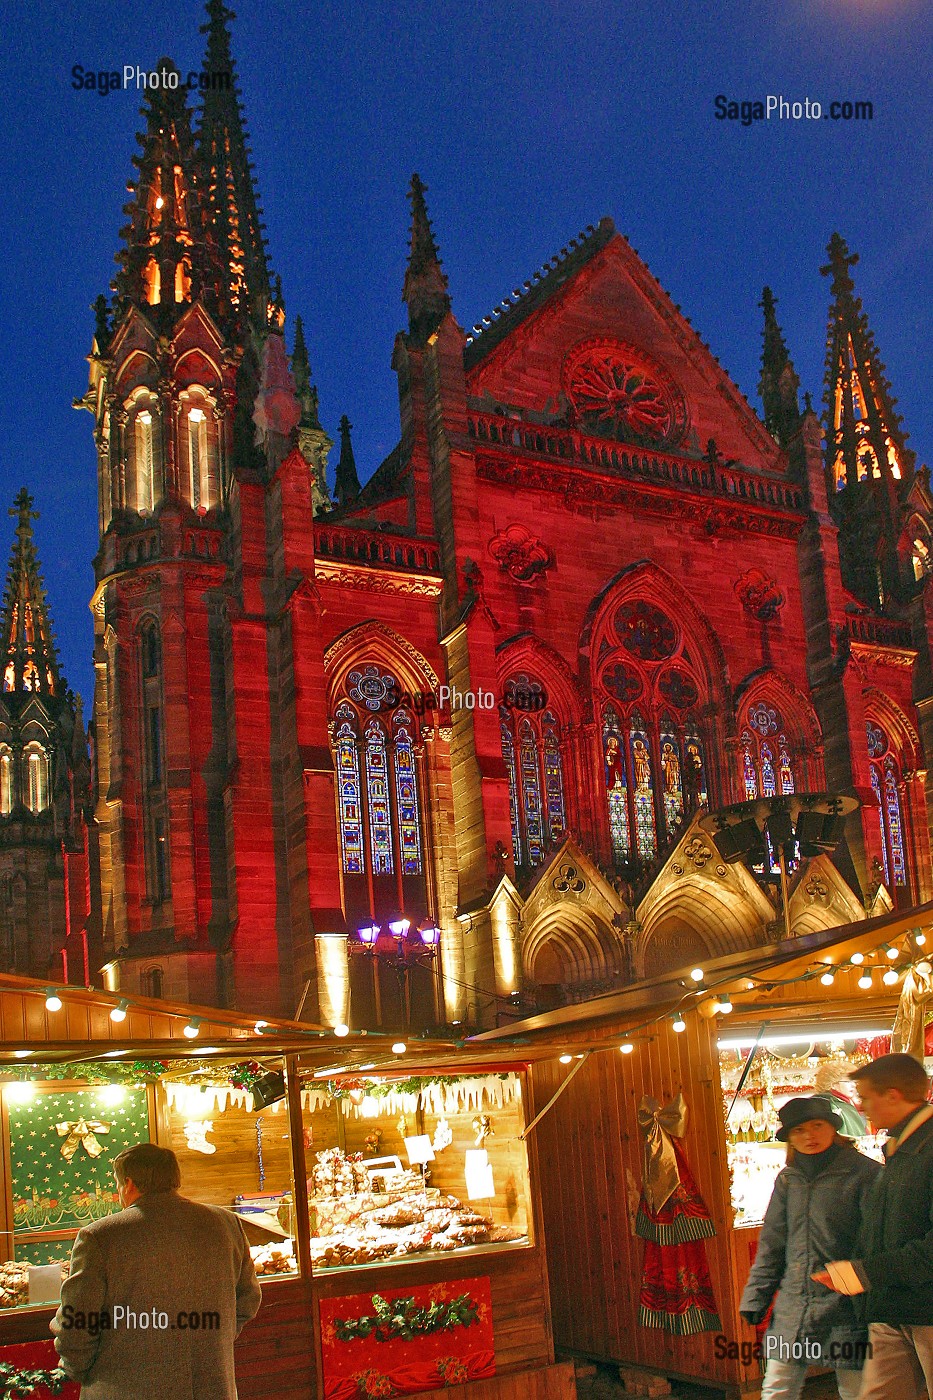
465, 220, 785, 470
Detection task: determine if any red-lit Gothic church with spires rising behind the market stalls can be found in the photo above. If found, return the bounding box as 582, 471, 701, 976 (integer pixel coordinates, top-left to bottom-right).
0, 0, 933, 1028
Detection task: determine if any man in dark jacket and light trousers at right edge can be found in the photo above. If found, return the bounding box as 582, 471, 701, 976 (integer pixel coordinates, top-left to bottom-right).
814, 1054, 933, 1400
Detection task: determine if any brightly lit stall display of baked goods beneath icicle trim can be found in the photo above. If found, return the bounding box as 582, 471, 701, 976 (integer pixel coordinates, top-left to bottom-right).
301, 1074, 531, 1270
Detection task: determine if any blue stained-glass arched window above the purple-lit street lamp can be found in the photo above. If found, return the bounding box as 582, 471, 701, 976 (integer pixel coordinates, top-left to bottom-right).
333, 666, 424, 892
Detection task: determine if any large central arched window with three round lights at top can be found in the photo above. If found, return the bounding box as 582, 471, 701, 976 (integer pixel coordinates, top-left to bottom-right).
595, 598, 709, 864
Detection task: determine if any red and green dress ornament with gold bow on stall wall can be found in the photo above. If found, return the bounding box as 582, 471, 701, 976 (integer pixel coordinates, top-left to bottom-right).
635, 1093, 721, 1337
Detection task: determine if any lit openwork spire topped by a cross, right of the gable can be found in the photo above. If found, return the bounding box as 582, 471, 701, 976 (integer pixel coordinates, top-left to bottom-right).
820, 234, 913, 503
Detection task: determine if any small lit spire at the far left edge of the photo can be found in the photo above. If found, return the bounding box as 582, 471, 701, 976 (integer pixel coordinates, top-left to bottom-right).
0, 486, 64, 696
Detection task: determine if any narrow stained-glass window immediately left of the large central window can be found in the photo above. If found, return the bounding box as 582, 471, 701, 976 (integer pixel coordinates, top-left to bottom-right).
499, 675, 567, 865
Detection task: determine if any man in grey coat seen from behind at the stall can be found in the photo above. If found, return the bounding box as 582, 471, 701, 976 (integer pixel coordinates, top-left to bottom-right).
50, 1142, 262, 1400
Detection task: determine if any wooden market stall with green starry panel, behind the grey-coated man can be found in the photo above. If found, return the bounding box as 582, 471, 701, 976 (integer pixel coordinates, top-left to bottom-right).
0, 976, 574, 1400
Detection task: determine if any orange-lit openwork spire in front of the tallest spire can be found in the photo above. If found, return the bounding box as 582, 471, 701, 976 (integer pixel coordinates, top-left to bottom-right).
113, 59, 220, 318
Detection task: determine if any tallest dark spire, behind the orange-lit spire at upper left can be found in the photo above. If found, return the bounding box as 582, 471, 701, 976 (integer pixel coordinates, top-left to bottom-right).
198, 0, 272, 326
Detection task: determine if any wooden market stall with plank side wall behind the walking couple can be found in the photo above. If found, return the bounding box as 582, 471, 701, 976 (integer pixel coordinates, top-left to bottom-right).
481, 906, 933, 1394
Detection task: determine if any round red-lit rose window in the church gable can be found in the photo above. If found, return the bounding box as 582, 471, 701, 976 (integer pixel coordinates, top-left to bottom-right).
563, 340, 686, 447
